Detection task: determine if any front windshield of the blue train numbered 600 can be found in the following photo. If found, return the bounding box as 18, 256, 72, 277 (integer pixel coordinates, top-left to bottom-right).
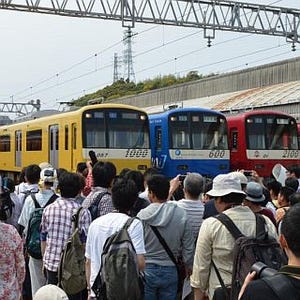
169, 112, 228, 150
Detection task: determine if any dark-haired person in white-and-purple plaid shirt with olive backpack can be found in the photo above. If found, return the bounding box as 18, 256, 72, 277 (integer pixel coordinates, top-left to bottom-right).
41, 172, 91, 300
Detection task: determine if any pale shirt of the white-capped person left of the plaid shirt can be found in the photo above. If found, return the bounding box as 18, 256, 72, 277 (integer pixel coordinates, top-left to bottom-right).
18, 189, 54, 235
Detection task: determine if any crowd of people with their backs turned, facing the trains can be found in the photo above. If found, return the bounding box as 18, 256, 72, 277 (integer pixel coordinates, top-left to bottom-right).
0, 161, 300, 300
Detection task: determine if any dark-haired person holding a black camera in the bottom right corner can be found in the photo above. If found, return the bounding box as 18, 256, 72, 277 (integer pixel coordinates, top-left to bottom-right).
239, 203, 300, 300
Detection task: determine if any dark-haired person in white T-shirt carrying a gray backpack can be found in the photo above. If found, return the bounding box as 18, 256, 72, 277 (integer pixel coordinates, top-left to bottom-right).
85, 178, 145, 297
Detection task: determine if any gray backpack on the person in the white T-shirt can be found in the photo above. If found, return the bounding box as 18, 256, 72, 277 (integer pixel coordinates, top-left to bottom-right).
92, 218, 143, 300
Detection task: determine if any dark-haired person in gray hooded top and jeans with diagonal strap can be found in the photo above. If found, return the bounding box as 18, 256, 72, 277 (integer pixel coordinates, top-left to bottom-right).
137, 175, 195, 300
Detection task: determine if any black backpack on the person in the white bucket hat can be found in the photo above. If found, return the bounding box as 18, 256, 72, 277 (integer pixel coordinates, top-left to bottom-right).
213, 213, 286, 300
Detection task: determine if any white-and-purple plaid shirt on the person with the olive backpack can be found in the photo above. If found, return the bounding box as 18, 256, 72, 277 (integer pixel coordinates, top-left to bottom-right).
41, 198, 91, 272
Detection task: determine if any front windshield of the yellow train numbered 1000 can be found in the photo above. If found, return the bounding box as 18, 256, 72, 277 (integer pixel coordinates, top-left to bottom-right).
82, 109, 150, 149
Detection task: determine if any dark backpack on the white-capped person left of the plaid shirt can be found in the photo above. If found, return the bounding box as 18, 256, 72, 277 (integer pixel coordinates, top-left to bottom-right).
25, 194, 58, 259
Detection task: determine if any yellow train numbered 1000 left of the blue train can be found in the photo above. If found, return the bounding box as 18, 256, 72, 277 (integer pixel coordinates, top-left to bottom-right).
0, 104, 151, 176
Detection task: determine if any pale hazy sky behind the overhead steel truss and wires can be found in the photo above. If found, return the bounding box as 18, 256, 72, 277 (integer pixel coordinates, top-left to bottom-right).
0, 0, 300, 118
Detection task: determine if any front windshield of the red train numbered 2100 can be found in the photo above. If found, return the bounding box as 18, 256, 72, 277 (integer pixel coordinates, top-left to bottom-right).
246, 115, 298, 150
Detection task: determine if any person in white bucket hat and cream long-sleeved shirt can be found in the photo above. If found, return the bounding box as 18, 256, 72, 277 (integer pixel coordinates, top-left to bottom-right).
190, 174, 277, 300
